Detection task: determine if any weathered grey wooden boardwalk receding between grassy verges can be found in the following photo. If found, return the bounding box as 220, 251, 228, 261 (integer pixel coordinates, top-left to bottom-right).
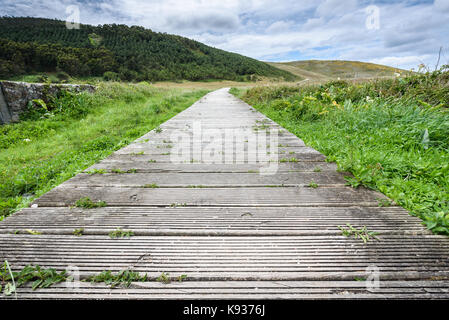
0, 89, 449, 299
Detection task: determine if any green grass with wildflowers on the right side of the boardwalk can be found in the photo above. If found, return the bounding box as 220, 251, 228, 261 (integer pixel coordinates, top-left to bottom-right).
232, 68, 449, 235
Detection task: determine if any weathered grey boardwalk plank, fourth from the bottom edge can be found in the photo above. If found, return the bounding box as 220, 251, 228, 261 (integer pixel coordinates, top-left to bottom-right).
34, 186, 385, 207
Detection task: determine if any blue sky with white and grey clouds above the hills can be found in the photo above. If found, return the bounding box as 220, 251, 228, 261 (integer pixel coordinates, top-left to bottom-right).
0, 0, 449, 70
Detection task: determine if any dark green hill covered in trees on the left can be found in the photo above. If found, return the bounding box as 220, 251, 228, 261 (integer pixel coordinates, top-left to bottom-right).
0, 17, 295, 81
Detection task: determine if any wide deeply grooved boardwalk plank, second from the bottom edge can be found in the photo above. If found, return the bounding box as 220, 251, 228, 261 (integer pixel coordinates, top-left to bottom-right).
0, 235, 449, 280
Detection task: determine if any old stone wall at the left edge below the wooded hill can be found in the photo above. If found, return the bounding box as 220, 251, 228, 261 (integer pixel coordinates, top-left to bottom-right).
0, 81, 95, 124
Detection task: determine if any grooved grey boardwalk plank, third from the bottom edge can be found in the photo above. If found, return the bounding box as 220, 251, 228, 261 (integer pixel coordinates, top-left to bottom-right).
0, 207, 428, 235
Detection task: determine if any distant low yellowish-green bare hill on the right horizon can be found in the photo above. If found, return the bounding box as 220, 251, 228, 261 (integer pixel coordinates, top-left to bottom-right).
269, 60, 405, 81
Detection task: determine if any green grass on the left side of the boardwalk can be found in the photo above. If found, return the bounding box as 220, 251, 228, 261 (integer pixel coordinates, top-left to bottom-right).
0, 83, 207, 220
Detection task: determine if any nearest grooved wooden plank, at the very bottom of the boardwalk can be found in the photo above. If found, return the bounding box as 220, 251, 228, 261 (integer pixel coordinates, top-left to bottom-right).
8, 281, 449, 299
